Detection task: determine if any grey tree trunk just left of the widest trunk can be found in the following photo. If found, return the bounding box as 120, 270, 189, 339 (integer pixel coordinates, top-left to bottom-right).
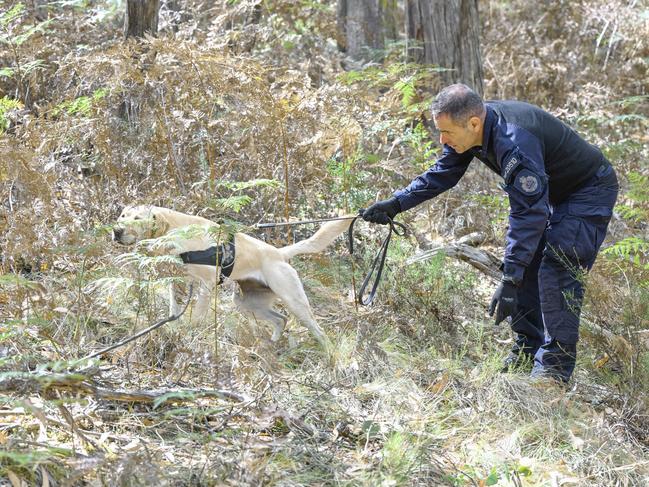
337, 0, 384, 61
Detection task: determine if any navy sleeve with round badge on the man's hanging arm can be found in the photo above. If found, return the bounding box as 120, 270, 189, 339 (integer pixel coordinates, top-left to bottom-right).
500, 130, 550, 282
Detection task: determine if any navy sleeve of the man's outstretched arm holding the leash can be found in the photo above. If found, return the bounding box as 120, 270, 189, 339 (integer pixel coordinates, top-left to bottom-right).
394, 145, 473, 211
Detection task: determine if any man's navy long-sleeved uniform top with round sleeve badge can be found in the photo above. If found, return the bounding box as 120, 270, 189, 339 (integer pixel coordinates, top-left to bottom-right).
394, 101, 608, 281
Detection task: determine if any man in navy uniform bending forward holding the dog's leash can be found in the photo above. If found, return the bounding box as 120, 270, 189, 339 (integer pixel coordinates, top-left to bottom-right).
362, 84, 618, 382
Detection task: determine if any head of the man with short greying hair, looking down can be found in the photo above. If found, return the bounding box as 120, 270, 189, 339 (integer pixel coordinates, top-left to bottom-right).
431, 84, 486, 154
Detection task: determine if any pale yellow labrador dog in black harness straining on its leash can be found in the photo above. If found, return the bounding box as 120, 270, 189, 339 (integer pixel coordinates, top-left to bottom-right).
113, 205, 351, 348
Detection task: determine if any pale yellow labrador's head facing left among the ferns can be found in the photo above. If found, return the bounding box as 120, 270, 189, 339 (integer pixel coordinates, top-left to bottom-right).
113, 206, 169, 245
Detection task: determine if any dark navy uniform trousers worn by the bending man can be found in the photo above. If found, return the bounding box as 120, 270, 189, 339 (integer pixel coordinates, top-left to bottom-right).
512, 165, 618, 381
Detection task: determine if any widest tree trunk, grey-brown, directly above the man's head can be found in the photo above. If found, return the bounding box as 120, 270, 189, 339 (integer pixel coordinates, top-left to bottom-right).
406, 0, 483, 94
